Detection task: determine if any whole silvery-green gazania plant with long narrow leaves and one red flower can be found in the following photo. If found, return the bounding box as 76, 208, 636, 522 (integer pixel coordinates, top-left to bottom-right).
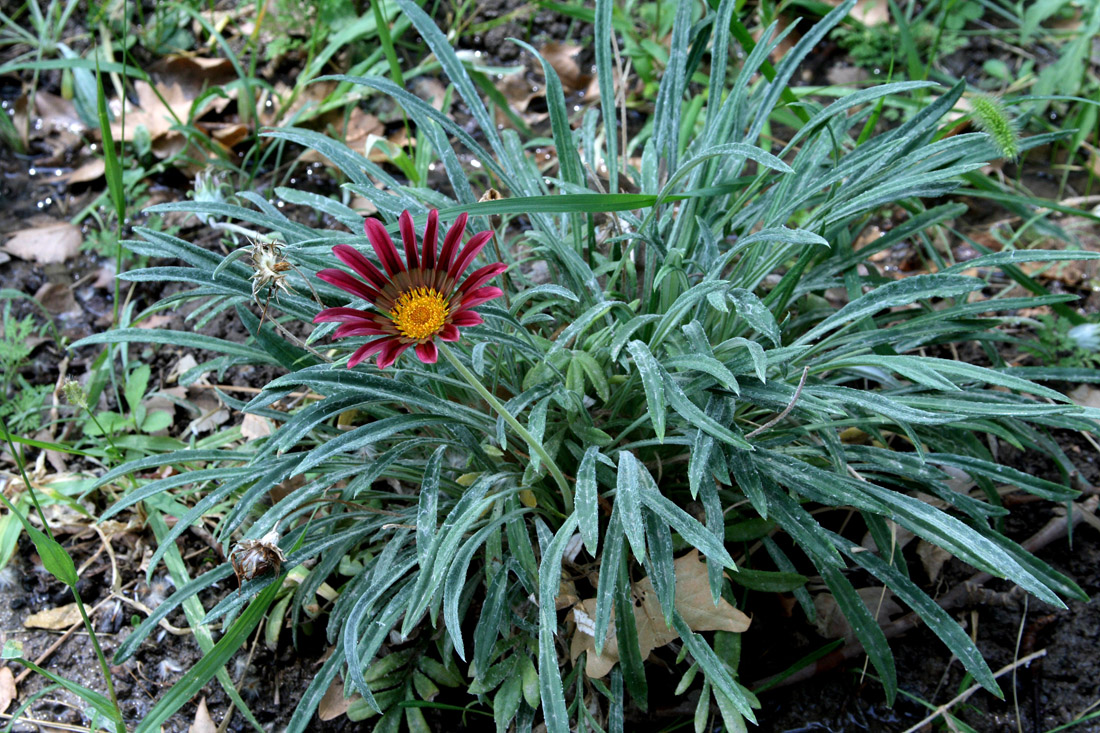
70, 0, 1097, 733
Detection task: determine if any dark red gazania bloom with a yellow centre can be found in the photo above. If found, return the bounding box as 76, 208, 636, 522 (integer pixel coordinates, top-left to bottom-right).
314, 209, 507, 369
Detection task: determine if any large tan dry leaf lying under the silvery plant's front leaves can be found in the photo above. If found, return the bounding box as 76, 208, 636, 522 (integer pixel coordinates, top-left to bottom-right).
570, 550, 751, 678
